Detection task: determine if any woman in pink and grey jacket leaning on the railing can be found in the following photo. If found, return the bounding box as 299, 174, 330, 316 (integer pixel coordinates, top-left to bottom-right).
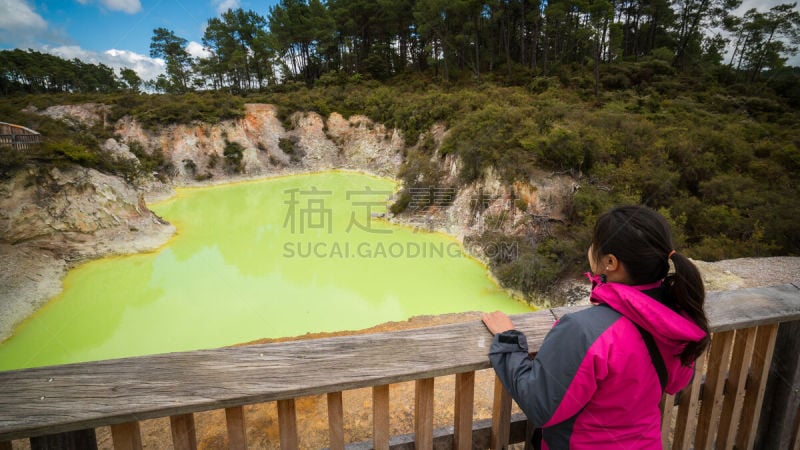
483, 206, 709, 449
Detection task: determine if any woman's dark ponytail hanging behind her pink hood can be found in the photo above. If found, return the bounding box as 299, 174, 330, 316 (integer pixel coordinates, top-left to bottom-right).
664, 253, 711, 366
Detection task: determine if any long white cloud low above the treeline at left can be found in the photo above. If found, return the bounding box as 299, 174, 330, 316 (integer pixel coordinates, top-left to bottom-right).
42, 45, 166, 80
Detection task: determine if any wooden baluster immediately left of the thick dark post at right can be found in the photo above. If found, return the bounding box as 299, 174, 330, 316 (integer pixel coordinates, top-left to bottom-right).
736, 323, 778, 448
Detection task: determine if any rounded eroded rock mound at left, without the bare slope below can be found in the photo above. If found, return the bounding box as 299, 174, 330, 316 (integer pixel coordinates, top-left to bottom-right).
0, 166, 173, 259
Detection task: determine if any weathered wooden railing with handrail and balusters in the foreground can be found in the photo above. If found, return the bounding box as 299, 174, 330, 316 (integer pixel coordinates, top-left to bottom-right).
0, 284, 800, 450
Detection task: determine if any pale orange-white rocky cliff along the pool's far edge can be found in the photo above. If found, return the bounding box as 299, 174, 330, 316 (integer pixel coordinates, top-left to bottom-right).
108, 104, 404, 184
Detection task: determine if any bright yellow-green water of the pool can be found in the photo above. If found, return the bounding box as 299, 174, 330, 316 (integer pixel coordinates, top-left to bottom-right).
0, 172, 530, 370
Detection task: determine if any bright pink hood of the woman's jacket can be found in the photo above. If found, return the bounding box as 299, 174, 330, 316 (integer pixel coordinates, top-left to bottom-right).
586, 273, 706, 352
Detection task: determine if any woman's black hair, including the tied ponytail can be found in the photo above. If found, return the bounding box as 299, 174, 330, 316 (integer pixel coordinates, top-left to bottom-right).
592, 206, 710, 366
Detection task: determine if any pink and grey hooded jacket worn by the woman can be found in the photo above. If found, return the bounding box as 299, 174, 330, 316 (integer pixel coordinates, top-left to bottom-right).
489, 277, 705, 449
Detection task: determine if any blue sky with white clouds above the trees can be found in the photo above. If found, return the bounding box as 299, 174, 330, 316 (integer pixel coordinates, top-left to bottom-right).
0, 0, 800, 80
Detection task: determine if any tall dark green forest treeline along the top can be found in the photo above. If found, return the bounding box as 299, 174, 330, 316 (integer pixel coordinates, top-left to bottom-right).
0, 0, 800, 94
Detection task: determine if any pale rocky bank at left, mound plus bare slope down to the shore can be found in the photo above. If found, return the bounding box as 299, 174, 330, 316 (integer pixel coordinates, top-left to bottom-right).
0, 166, 175, 341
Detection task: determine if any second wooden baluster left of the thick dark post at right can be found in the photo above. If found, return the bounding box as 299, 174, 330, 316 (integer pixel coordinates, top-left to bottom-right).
717, 327, 756, 450
